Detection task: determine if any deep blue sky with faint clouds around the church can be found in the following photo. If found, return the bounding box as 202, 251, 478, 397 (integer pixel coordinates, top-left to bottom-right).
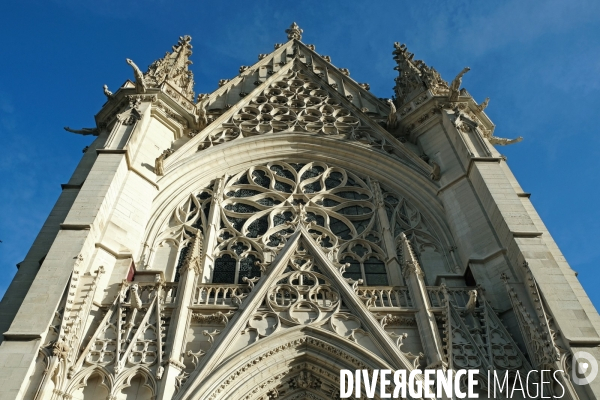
0, 0, 600, 306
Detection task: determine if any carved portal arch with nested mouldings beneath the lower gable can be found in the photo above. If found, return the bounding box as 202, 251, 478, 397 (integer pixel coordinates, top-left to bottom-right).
175, 326, 393, 400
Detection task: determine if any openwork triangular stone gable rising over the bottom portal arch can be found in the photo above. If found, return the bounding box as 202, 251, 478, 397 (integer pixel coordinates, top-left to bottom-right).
180, 228, 426, 396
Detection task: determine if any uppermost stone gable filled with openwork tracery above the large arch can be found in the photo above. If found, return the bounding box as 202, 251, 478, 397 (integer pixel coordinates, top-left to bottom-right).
165, 60, 431, 177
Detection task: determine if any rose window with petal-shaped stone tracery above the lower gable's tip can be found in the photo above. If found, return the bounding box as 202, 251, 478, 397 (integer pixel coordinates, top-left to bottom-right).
221, 162, 375, 247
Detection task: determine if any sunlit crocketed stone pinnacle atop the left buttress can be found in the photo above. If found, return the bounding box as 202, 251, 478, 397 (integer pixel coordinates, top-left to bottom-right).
144, 35, 194, 101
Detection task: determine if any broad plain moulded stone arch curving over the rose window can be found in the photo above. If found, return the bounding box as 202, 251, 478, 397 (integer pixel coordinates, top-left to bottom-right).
139, 133, 453, 263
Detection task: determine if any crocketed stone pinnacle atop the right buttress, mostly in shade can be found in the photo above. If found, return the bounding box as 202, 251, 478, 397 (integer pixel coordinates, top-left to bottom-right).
392, 42, 449, 106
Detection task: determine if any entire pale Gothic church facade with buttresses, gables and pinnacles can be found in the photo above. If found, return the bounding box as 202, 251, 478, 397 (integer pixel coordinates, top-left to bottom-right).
0, 24, 600, 400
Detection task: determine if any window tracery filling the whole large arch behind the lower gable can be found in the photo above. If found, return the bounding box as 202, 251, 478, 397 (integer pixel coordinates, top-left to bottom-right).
146, 161, 452, 285
